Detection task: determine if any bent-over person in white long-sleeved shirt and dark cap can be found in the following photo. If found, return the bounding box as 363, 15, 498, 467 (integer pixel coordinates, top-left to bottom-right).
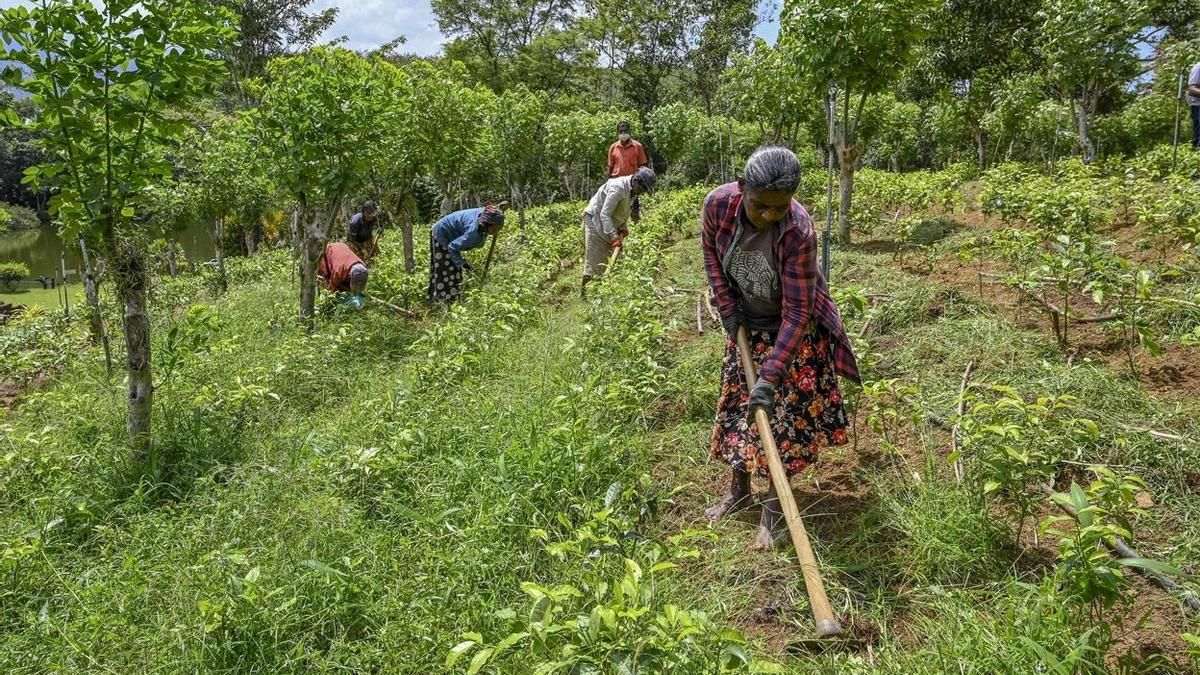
580, 167, 655, 298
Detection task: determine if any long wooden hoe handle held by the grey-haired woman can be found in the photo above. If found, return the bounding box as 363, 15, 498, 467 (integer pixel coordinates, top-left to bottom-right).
738, 325, 842, 638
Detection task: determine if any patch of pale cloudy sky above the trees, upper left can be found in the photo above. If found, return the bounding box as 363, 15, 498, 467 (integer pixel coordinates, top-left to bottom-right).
309, 0, 445, 55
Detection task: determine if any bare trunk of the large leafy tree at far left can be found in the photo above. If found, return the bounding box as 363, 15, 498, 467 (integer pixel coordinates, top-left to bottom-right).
109, 238, 154, 461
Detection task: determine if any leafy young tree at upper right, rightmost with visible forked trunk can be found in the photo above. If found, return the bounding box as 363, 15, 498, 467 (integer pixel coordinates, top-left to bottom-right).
1038, 0, 1146, 163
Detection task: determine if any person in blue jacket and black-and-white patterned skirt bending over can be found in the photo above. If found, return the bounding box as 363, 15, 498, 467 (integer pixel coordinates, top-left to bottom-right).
428, 204, 504, 304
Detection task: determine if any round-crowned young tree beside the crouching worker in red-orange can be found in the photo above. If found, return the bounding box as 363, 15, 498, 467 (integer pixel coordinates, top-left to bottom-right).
256, 47, 392, 328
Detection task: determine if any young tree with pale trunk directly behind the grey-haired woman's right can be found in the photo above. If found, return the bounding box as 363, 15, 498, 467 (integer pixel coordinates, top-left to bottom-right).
780, 0, 929, 244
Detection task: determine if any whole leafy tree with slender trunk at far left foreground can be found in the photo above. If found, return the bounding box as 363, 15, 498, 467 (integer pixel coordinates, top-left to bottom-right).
0, 0, 233, 459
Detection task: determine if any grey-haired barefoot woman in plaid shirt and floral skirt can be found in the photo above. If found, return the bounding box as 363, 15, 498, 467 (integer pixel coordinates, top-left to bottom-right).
701, 147, 859, 548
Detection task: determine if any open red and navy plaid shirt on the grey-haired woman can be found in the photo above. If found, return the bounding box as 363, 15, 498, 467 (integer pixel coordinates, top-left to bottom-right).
701, 183, 860, 384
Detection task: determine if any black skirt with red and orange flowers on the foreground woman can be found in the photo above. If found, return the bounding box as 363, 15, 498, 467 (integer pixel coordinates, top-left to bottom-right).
710, 322, 848, 477
